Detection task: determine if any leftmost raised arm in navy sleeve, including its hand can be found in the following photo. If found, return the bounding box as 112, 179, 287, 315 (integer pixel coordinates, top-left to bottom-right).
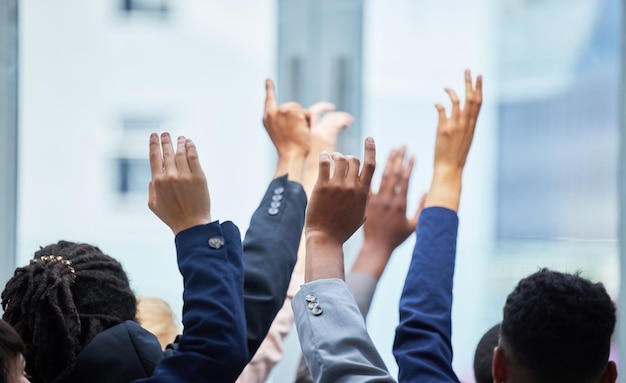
141, 133, 248, 382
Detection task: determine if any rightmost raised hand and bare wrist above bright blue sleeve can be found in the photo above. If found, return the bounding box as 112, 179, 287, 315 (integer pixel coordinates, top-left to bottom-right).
425, 70, 482, 211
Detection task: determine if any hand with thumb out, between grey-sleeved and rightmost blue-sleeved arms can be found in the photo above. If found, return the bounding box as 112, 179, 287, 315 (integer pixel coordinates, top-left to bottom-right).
363, 146, 424, 257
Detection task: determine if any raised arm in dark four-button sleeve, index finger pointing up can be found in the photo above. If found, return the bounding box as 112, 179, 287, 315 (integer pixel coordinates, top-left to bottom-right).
243, 80, 310, 358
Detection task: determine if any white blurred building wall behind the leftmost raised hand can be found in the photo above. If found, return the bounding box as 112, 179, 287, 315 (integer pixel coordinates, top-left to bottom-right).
18, 0, 276, 320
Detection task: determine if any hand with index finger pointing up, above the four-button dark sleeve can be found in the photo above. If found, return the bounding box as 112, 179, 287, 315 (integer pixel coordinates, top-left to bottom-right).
263, 79, 310, 158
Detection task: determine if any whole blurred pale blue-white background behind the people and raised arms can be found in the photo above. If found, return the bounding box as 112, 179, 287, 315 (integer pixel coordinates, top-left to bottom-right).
0, 0, 626, 382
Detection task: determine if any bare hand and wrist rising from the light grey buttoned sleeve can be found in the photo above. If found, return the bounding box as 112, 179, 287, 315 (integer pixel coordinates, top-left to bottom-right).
304, 137, 376, 281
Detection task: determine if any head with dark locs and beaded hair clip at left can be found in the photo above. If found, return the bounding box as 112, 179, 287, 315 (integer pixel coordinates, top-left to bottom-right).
2, 241, 136, 382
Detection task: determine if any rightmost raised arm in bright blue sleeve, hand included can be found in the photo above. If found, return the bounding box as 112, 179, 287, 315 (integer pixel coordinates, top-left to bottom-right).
393, 71, 482, 383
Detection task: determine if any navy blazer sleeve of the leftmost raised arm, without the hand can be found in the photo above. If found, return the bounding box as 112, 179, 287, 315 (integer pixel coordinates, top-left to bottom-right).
136, 222, 248, 383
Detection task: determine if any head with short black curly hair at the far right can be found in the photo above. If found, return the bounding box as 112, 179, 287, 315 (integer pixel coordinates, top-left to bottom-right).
500, 269, 616, 383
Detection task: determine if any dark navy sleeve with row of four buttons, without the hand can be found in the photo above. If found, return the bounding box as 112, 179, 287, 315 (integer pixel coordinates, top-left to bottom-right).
243, 176, 306, 359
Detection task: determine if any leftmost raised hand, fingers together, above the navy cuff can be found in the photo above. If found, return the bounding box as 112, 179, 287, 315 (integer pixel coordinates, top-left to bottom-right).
148, 133, 211, 235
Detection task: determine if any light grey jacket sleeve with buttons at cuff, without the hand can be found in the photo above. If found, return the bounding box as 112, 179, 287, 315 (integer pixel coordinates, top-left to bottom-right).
291, 279, 395, 383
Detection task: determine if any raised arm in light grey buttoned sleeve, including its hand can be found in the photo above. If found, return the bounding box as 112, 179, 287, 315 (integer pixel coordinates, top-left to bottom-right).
292, 138, 393, 382
